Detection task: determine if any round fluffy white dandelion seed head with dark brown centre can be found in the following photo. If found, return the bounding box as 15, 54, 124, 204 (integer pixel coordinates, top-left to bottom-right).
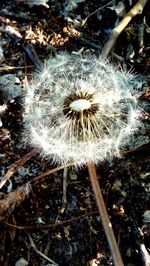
24, 53, 139, 165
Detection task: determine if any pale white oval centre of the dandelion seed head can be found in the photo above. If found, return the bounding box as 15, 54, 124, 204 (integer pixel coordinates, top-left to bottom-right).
70, 99, 91, 112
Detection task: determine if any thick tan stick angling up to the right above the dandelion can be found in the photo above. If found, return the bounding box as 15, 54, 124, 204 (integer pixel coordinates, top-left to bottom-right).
102, 0, 148, 57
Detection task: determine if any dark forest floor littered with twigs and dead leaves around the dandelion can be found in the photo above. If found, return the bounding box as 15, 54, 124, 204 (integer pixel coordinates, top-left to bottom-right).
0, 0, 150, 266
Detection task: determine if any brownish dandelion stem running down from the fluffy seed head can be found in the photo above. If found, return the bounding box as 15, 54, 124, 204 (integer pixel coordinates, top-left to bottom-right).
88, 163, 124, 266
